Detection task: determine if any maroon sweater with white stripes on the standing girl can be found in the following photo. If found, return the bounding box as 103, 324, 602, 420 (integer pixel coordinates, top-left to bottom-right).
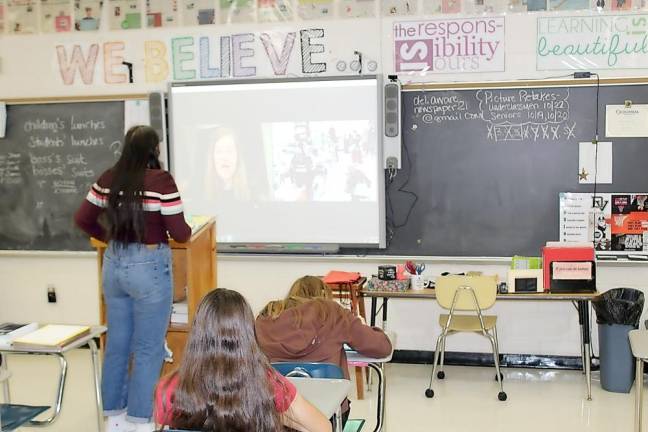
74, 169, 191, 244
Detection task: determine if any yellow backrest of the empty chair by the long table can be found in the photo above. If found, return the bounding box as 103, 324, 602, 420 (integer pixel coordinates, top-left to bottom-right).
434, 275, 497, 311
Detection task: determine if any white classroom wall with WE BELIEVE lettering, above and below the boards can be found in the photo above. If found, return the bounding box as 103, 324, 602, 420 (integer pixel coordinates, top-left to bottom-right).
0, 7, 648, 355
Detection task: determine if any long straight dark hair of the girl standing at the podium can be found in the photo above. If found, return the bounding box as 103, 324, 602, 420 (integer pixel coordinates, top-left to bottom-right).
106, 126, 160, 243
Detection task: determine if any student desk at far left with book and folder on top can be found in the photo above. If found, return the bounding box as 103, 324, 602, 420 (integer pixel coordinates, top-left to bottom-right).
0, 326, 106, 431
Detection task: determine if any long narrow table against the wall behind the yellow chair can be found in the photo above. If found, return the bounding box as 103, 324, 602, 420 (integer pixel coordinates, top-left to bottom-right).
360, 289, 598, 400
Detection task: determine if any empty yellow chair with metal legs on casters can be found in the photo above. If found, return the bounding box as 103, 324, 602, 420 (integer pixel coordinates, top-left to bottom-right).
425, 276, 506, 401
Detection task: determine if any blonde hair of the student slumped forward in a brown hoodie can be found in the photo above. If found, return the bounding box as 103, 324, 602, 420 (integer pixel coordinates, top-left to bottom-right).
259, 276, 333, 327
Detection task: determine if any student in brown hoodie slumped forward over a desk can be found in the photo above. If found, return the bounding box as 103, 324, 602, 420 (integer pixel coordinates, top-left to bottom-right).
256, 276, 392, 423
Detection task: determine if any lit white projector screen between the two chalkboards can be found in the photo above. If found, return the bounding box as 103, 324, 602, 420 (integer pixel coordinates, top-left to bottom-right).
169, 76, 385, 247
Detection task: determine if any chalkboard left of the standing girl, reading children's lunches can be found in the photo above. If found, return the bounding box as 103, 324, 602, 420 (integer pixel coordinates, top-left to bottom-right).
0, 102, 124, 250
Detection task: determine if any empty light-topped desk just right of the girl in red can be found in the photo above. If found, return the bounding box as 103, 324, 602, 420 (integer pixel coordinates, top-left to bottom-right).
288, 377, 351, 432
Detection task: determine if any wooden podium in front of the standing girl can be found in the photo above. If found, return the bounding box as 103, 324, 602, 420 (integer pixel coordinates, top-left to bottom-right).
90, 219, 216, 374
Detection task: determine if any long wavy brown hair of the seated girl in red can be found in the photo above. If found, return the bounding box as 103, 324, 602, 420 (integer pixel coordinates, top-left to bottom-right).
170, 288, 283, 432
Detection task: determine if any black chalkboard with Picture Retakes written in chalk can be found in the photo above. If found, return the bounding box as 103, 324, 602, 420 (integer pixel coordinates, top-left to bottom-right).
364, 85, 648, 256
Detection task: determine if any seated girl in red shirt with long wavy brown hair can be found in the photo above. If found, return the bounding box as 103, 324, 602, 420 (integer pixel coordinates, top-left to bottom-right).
155, 289, 331, 432
